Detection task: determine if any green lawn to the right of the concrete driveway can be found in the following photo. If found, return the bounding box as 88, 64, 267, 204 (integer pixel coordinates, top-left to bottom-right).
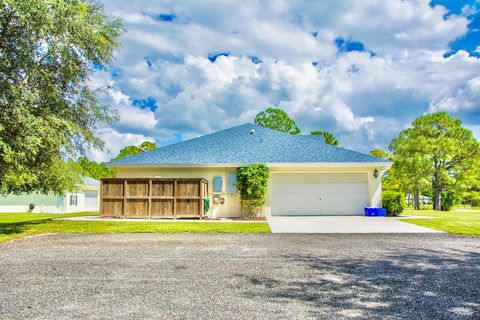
401, 209, 480, 236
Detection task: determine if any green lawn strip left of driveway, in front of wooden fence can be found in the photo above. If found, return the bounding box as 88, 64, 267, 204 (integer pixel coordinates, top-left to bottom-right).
0, 212, 271, 243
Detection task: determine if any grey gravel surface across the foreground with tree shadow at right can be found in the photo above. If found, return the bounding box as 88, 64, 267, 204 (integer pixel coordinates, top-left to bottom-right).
0, 234, 480, 319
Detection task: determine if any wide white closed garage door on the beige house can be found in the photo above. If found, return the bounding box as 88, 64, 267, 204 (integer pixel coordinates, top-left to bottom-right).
270, 173, 368, 216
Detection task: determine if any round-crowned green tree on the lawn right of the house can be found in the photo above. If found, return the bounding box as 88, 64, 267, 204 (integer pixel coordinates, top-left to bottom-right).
390, 112, 480, 210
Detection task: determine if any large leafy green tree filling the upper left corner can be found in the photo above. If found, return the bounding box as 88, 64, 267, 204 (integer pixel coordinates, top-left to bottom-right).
0, 0, 122, 194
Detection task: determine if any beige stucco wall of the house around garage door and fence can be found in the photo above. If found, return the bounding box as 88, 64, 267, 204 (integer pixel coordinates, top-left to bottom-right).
117, 167, 382, 217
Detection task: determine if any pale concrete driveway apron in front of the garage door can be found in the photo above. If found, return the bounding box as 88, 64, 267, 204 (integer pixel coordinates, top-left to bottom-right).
268, 216, 442, 233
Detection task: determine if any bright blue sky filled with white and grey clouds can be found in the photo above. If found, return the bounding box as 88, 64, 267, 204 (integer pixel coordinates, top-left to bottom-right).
88, 0, 480, 161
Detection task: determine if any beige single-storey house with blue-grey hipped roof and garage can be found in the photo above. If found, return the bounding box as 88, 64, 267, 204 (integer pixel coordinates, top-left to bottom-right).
107, 124, 391, 217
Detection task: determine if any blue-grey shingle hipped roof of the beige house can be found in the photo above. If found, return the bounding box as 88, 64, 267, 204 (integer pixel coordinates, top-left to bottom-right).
109, 124, 388, 167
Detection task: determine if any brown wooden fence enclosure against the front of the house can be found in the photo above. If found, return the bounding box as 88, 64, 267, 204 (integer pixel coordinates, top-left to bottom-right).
100, 178, 208, 219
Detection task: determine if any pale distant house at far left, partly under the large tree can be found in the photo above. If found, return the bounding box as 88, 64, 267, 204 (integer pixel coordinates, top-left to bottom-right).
0, 177, 100, 213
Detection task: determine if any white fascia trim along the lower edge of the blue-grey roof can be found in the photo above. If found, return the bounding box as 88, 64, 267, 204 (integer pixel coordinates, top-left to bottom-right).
105, 162, 393, 169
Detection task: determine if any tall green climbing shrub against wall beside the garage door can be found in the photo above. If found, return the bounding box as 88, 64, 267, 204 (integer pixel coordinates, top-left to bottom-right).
237, 163, 270, 216
